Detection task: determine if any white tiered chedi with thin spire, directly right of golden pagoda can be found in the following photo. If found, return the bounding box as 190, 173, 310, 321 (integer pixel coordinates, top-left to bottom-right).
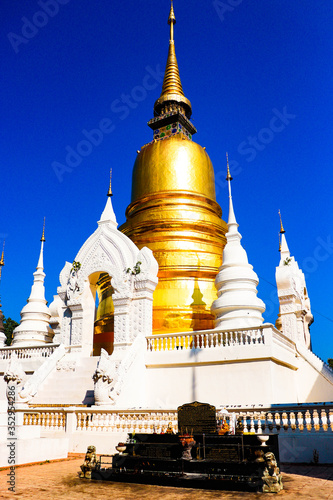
211, 163, 265, 330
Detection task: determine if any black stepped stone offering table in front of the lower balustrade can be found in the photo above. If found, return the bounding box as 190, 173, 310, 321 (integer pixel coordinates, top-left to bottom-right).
91, 434, 282, 492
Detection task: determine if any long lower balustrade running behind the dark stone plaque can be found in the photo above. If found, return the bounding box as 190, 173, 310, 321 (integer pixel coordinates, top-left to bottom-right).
17, 403, 333, 434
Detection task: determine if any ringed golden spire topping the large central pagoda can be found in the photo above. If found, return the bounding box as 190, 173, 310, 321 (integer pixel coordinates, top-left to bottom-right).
154, 1, 192, 118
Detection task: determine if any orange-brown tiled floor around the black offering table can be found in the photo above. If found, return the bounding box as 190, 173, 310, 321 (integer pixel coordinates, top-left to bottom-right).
0, 455, 333, 500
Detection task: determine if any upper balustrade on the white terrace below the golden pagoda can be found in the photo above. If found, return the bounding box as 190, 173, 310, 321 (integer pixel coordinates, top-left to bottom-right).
146, 328, 265, 352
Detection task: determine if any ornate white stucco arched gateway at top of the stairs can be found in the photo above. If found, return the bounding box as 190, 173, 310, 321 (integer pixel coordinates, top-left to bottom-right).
50, 197, 158, 355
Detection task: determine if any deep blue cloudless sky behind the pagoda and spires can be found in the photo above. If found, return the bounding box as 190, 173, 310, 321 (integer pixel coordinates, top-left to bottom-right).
0, 0, 333, 360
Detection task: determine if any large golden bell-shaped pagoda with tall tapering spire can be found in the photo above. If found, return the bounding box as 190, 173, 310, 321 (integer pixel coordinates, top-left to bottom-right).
120, 2, 227, 333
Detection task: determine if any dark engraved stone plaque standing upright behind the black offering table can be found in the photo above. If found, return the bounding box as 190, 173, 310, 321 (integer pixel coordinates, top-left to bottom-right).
178, 401, 216, 434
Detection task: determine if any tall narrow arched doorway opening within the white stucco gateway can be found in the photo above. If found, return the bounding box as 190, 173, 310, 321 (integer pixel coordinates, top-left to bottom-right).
93, 273, 114, 356
